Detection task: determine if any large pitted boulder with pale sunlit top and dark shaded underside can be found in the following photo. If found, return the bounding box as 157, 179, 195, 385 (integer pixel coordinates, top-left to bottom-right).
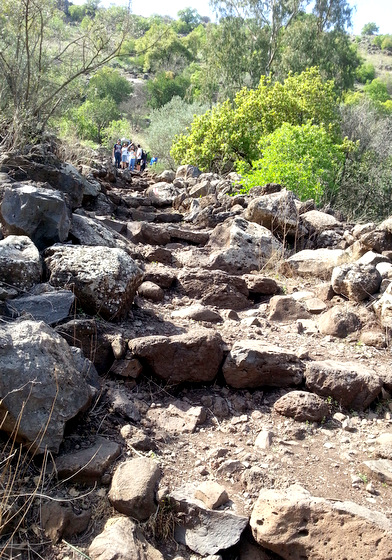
45, 245, 143, 320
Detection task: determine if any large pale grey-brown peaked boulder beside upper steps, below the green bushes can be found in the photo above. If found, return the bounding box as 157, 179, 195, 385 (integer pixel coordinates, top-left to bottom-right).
208, 217, 284, 274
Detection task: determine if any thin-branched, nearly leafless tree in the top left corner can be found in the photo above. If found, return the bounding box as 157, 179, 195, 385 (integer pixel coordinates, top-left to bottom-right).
0, 0, 132, 146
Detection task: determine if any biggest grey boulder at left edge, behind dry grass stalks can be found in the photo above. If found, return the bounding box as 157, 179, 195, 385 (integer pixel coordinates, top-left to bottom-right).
0, 321, 92, 453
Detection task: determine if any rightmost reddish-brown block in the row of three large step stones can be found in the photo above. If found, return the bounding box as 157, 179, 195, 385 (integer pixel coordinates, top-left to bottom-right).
305, 360, 382, 410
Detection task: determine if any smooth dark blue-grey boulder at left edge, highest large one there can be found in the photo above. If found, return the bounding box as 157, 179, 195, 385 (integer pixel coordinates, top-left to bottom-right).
0, 183, 71, 249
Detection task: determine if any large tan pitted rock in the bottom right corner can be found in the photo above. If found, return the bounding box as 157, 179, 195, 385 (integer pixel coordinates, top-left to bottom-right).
250, 487, 392, 560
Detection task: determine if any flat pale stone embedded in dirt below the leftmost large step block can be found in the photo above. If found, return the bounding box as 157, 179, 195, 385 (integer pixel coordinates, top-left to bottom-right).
146, 401, 206, 434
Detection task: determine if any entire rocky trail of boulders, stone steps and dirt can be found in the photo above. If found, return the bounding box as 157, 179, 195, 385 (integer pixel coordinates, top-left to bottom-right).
0, 146, 392, 560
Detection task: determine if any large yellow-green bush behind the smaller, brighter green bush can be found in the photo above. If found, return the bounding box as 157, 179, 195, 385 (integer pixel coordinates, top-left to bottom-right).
171, 68, 338, 171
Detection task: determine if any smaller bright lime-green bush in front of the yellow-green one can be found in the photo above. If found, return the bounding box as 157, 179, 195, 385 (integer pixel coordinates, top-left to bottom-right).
237, 123, 344, 202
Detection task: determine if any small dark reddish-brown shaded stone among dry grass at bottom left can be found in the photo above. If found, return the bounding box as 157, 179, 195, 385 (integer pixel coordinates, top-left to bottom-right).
41, 502, 91, 543
